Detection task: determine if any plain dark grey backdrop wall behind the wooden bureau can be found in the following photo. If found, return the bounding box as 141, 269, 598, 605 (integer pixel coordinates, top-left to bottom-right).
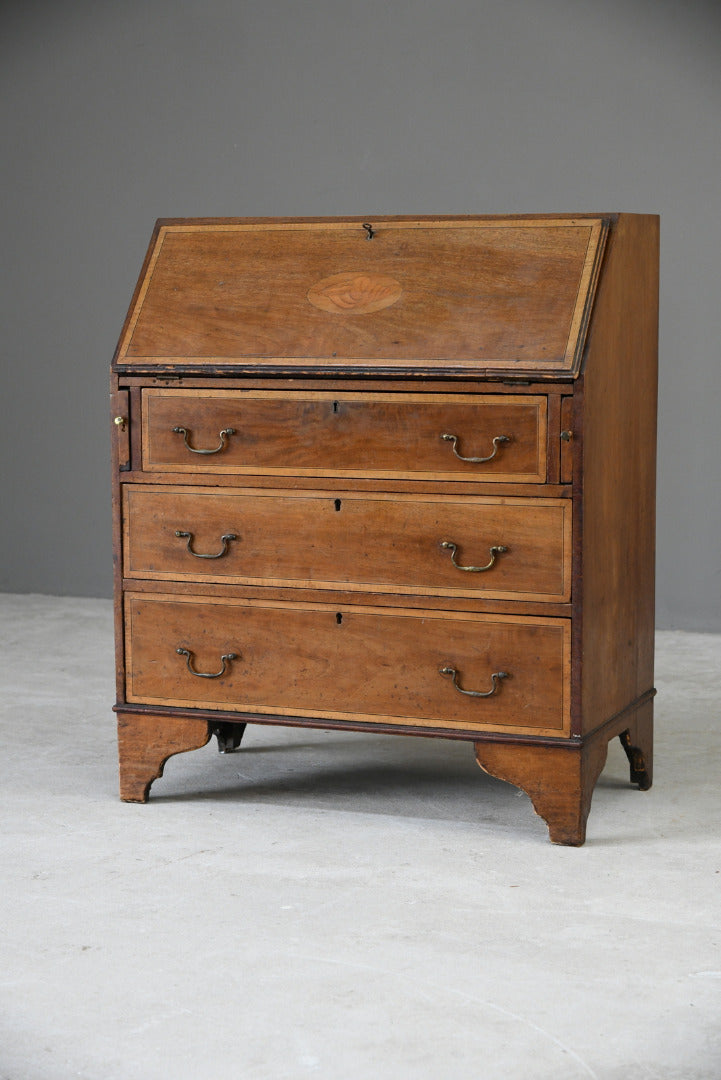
0, 0, 721, 630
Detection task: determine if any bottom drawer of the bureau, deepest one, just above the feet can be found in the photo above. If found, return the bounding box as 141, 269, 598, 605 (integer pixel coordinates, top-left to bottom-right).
125, 594, 570, 735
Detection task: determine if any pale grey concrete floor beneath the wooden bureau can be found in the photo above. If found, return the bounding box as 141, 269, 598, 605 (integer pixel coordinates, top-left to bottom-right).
0, 596, 721, 1080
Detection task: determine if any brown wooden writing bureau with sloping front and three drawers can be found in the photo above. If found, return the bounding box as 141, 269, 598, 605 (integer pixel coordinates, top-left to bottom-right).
112, 214, 658, 845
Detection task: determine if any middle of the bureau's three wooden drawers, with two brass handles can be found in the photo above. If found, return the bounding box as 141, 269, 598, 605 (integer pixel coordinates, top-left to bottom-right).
124, 485, 571, 603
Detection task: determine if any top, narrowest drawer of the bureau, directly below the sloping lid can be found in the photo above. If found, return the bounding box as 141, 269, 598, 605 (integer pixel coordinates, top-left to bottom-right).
142, 388, 547, 483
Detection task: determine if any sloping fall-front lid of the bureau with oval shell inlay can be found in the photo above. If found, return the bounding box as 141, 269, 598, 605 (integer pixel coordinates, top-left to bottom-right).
118, 217, 607, 373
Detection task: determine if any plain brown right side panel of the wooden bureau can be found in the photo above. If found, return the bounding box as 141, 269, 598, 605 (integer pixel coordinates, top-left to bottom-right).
574, 214, 658, 732
